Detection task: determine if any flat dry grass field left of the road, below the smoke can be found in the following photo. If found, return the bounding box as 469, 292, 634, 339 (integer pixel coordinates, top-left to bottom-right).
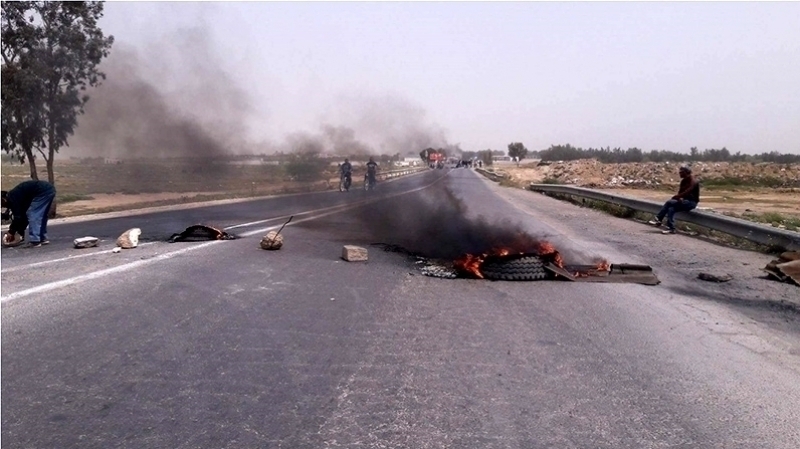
1, 159, 338, 216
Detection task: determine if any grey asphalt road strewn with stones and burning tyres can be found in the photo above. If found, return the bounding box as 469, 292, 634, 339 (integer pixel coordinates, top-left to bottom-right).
1, 169, 800, 448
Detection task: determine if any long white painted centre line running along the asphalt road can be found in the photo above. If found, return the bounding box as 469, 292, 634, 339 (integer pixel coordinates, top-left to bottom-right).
0, 173, 442, 303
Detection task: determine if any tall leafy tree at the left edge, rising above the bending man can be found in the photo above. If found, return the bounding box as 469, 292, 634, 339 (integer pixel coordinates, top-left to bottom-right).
2, 1, 114, 210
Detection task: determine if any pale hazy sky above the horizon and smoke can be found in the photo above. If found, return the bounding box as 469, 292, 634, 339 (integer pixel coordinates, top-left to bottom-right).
90, 2, 800, 153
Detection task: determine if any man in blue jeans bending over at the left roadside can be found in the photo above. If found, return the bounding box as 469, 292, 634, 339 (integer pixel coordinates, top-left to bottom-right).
2, 180, 56, 247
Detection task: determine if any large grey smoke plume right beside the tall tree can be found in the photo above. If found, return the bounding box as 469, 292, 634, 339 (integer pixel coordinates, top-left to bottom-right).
71, 29, 250, 159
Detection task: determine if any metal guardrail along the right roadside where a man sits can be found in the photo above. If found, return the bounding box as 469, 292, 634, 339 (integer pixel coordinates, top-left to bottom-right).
529, 184, 800, 251
